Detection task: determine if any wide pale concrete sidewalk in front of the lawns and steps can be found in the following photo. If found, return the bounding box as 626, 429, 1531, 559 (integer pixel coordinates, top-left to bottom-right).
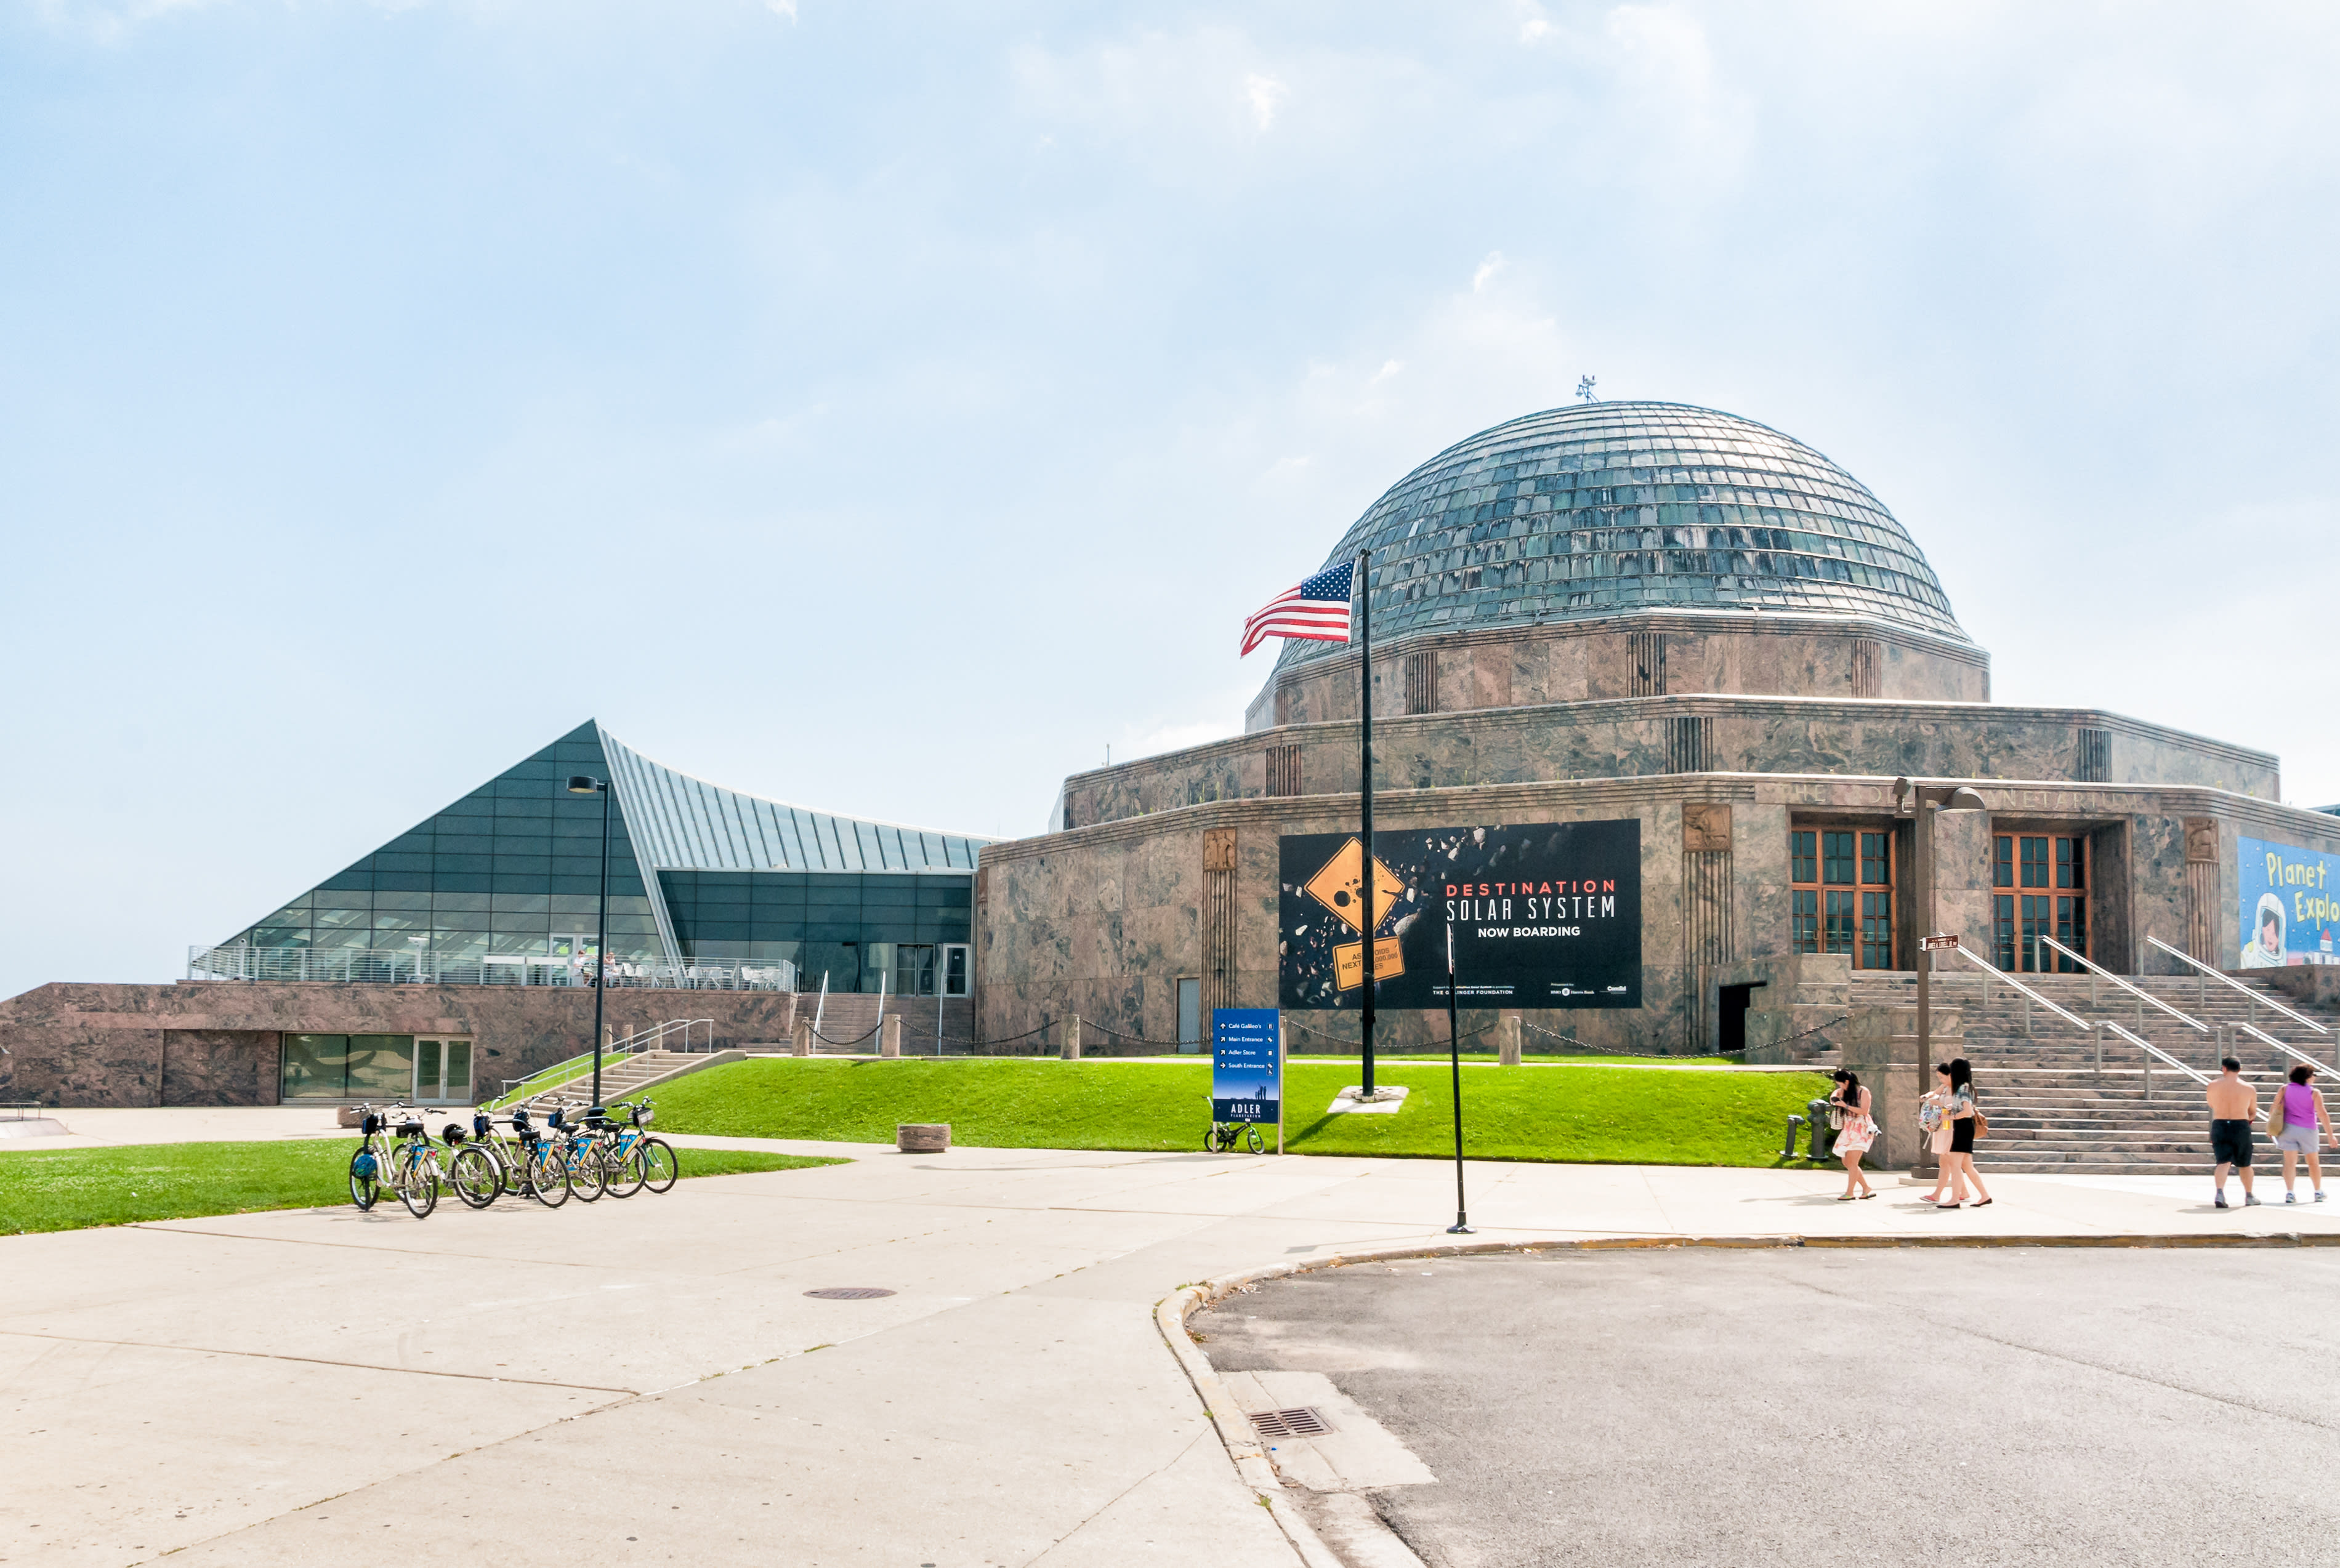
0, 1140, 2340, 1568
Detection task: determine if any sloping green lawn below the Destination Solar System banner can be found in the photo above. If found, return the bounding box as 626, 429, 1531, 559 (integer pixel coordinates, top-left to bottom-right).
650, 1058, 1828, 1165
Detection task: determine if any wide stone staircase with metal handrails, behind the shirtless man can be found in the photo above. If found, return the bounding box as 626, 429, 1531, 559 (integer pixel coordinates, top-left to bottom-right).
1820, 969, 2340, 1175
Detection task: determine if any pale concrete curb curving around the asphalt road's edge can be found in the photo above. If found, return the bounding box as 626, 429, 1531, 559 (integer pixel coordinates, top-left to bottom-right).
1153, 1231, 2340, 1568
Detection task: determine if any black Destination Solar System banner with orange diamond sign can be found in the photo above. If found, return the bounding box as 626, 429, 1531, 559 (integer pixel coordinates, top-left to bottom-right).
1278, 817, 1640, 1011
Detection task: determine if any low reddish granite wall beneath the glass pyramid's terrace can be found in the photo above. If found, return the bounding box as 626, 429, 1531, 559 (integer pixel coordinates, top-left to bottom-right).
0, 981, 796, 1104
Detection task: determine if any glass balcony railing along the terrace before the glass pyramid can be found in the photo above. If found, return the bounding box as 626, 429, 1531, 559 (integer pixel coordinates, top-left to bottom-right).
187, 946, 796, 990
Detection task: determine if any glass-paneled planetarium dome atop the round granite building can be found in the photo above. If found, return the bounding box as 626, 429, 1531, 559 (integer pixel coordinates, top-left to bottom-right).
1278, 403, 1972, 669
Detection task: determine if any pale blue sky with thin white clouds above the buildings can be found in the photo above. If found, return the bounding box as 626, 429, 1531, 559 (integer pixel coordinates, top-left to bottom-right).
0, 0, 2340, 995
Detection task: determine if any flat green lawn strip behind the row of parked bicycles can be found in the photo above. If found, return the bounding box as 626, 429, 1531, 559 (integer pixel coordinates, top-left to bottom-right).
0, 1135, 837, 1236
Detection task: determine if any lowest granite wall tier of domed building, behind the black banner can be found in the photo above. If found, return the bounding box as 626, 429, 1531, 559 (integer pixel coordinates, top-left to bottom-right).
976, 772, 2340, 1051
